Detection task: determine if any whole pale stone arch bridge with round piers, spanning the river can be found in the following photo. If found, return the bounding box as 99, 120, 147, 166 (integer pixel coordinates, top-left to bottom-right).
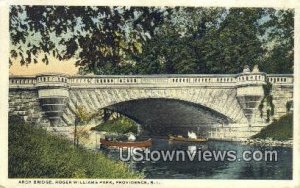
9, 71, 293, 139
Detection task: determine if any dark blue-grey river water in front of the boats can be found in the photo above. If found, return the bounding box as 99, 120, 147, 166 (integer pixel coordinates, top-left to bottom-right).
100, 139, 292, 179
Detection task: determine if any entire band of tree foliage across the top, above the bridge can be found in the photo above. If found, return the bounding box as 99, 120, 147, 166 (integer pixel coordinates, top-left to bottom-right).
10, 6, 294, 74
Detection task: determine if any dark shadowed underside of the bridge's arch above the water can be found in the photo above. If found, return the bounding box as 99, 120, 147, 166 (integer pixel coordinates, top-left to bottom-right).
106, 98, 231, 136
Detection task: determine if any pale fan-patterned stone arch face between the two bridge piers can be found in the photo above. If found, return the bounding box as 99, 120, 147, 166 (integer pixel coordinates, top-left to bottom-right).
62, 87, 247, 124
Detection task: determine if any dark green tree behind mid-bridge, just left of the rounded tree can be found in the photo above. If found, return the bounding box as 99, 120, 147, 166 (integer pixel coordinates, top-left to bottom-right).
136, 7, 224, 74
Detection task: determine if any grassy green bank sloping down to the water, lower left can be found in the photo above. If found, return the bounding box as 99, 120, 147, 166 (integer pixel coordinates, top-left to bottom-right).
8, 117, 143, 179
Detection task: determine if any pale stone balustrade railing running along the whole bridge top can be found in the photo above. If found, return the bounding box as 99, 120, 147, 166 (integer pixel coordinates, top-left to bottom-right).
9, 73, 294, 88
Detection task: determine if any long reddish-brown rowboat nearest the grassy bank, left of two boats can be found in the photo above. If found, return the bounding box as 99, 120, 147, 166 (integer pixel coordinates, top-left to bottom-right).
100, 138, 152, 148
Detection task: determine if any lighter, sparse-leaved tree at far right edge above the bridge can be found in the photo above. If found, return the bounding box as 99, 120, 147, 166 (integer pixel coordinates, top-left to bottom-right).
262, 9, 294, 73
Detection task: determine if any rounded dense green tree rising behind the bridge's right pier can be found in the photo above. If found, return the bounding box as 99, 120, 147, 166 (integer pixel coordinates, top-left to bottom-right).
203, 8, 264, 73
